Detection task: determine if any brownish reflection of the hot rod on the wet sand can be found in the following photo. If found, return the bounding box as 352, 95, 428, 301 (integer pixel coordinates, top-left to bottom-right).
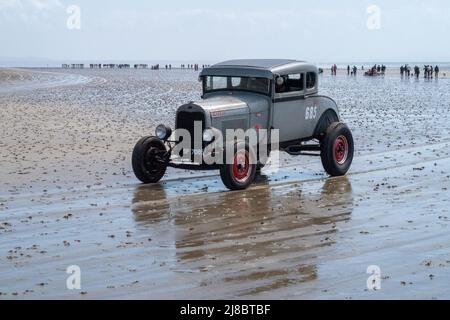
133, 177, 354, 297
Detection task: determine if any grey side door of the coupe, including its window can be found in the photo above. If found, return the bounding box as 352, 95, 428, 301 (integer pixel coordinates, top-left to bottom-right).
273, 73, 306, 142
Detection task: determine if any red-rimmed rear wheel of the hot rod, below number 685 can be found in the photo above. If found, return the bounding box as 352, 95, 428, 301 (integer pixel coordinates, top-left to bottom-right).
321, 122, 355, 177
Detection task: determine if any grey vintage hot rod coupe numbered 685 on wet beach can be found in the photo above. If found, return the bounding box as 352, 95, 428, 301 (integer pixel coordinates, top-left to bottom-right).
132, 59, 354, 190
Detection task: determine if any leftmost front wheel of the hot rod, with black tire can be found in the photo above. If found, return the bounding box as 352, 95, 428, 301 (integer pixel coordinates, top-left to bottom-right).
132, 137, 167, 184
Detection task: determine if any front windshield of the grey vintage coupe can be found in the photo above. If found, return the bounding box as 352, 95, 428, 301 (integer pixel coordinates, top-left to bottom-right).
203, 76, 270, 95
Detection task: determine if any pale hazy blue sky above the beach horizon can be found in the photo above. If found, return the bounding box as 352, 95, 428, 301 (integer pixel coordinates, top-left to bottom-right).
0, 0, 450, 62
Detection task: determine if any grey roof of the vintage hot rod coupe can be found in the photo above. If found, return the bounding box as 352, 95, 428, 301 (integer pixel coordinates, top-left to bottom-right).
200, 59, 317, 78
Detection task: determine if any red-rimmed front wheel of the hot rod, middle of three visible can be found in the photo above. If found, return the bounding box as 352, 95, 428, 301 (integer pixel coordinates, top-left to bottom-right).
220, 142, 257, 190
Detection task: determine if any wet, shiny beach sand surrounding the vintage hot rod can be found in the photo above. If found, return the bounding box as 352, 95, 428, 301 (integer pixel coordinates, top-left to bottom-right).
0, 66, 450, 299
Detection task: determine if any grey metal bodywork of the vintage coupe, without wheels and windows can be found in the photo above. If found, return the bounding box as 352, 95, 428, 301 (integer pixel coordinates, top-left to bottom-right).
176, 60, 339, 146
